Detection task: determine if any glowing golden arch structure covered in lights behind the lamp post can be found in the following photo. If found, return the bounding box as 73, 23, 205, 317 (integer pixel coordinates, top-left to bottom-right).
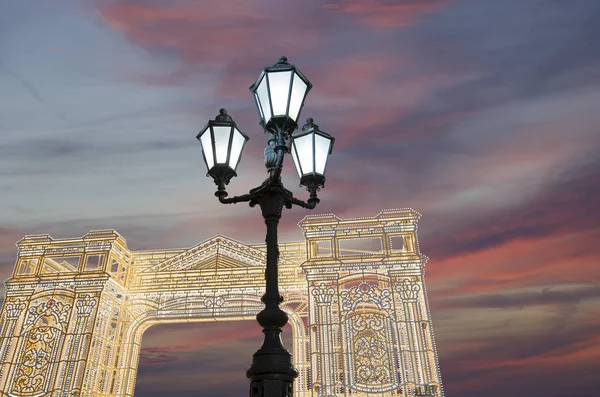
0, 209, 443, 397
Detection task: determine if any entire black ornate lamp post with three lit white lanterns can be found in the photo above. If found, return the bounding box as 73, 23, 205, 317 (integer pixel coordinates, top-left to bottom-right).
197, 57, 334, 397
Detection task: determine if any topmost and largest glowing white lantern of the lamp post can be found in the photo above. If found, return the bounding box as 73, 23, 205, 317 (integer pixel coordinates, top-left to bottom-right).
250, 56, 312, 135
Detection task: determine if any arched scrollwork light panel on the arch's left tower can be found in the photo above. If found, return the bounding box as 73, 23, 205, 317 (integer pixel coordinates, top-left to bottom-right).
10, 299, 70, 397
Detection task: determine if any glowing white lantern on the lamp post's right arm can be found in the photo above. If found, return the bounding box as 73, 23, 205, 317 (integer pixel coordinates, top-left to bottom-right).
291, 118, 335, 191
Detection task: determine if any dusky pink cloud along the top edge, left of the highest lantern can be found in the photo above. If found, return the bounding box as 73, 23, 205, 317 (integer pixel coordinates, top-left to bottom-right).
98, 0, 320, 90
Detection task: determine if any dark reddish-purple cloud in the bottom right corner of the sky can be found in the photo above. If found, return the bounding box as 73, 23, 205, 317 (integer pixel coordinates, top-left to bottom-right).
441, 325, 600, 396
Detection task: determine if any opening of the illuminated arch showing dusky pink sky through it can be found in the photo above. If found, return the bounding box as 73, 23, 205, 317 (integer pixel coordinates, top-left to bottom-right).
133, 319, 294, 397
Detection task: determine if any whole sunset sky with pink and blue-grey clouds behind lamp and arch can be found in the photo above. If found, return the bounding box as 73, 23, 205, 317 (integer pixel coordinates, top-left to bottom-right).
0, 0, 600, 397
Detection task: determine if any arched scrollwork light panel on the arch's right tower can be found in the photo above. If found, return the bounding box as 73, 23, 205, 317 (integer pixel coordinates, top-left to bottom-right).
340, 282, 400, 393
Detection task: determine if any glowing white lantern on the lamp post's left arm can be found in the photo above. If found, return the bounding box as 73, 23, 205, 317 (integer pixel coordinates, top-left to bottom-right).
196, 109, 249, 190
